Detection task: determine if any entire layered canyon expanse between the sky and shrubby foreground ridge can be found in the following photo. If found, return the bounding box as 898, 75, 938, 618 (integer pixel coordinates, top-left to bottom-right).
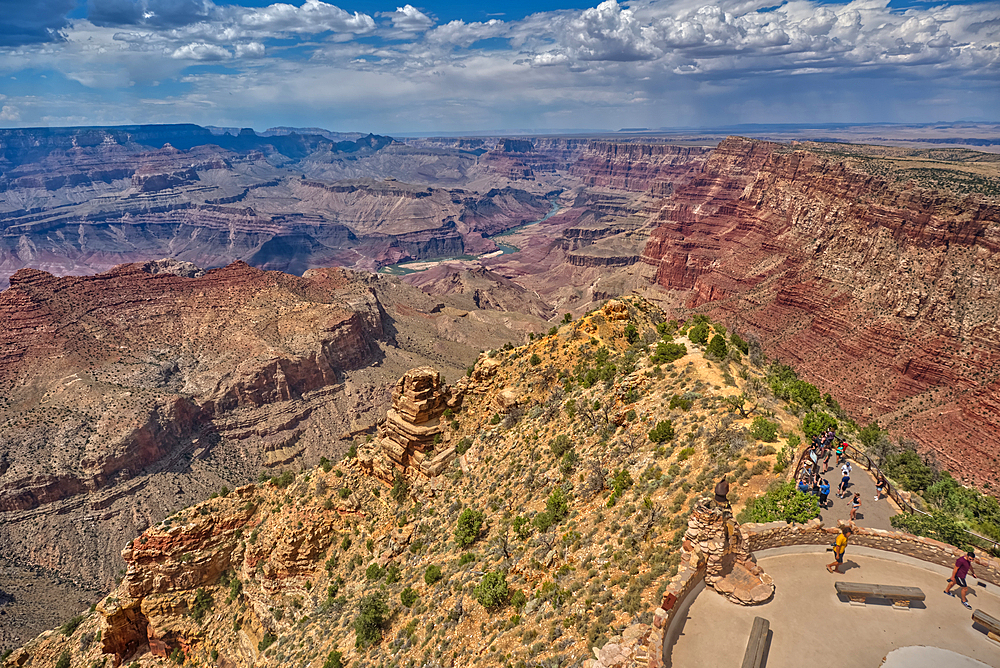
0, 125, 1000, 586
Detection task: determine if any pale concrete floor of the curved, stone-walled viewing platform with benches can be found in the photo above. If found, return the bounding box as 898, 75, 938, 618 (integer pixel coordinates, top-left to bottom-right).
664, 545, 1000, 668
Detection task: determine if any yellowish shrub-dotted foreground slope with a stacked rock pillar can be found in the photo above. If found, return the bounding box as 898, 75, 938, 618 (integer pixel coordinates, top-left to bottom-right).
7, 300, 808, 666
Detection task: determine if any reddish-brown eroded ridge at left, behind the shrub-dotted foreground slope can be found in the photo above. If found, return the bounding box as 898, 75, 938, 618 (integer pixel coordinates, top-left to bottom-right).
0, 261, 545, 600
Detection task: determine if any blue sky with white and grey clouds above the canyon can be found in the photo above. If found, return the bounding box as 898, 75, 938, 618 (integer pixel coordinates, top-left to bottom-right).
0, 0, 1000, 134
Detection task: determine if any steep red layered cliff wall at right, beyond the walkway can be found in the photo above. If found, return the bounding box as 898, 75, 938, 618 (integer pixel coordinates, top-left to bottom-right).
643, 138, 1000, 484
